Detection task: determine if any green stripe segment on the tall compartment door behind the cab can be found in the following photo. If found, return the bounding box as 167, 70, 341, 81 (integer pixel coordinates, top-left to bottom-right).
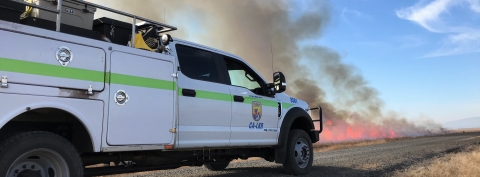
110, 73, 175, 90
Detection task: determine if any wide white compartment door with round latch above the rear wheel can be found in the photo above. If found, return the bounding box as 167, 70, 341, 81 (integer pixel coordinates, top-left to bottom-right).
0, 30, 105, 91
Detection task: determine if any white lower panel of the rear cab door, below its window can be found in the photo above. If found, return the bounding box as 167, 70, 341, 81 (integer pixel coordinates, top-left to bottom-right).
177, 72, 232, 148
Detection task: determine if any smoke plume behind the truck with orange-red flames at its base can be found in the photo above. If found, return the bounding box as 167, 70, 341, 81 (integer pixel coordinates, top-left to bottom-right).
92, 0, 446, 141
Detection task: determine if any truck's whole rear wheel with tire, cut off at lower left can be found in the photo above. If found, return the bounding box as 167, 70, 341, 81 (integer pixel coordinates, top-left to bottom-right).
0, 131, 84, 177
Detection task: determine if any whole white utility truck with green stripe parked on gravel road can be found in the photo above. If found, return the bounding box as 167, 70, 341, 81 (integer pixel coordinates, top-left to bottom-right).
0, 0, 322, 177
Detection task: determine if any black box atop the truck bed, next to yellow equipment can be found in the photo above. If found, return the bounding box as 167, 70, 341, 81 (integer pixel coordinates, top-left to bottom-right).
93, 17, 132, 45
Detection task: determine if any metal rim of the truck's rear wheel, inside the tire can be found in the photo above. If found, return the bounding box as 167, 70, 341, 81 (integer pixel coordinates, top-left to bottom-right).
7, 149, 70, 177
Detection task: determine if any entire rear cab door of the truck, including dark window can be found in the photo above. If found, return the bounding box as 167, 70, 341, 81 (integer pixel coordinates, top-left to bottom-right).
175, 44, 232, 148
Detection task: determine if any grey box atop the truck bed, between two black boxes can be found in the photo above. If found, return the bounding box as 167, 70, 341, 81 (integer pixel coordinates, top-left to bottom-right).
25, 0, 97, 30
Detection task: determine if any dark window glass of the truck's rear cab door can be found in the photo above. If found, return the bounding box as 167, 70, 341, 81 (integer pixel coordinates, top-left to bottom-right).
175, 45, 219, 82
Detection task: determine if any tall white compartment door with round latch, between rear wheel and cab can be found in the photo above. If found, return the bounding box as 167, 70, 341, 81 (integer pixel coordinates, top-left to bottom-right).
107, 51, 175, 145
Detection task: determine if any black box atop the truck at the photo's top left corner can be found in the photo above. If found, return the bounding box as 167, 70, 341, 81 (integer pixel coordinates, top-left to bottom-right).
0, 0, 25, 23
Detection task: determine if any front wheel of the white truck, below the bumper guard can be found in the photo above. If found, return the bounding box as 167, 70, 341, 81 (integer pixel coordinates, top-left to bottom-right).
283, 129, 313, 175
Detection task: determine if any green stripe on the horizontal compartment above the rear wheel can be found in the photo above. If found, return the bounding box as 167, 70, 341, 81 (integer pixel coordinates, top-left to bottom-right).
0, 58, 104, 82
